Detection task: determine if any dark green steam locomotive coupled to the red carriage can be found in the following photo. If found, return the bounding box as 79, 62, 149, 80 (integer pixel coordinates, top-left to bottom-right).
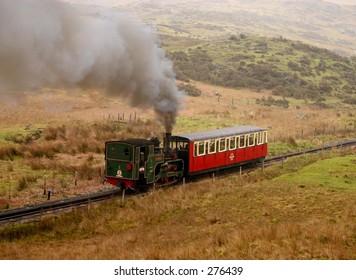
105, 139, 184, 189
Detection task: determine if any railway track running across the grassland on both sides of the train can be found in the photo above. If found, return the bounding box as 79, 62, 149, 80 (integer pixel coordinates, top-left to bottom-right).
0, 139, 356, 226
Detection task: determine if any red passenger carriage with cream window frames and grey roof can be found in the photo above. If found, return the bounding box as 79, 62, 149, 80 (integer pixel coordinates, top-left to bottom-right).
170, 126, 267, 175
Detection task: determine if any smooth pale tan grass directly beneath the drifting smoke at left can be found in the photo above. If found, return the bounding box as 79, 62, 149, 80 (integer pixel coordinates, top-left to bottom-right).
0, 89, 153, 128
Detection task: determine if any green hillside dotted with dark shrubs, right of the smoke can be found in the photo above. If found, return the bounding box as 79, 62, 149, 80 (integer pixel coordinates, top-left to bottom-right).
164, 34, 356, 104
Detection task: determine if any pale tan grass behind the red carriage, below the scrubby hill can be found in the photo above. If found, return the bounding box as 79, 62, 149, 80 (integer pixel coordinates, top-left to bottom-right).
178, 82, 356, 144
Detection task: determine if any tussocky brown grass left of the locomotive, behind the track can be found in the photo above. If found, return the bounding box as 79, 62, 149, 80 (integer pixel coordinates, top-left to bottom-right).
0, 113, 157, 209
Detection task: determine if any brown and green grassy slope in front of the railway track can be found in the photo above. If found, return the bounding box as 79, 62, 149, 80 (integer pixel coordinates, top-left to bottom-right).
0, 150, 356, 259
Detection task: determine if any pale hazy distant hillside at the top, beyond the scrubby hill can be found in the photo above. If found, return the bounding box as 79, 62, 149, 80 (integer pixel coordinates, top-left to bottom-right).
98, 0, 356, 56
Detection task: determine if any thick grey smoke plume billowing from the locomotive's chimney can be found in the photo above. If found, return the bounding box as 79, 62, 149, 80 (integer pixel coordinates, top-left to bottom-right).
0, 0, 182, 132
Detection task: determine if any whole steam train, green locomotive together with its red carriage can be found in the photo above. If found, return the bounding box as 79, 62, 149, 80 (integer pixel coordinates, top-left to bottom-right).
105, 126, 267, 190
